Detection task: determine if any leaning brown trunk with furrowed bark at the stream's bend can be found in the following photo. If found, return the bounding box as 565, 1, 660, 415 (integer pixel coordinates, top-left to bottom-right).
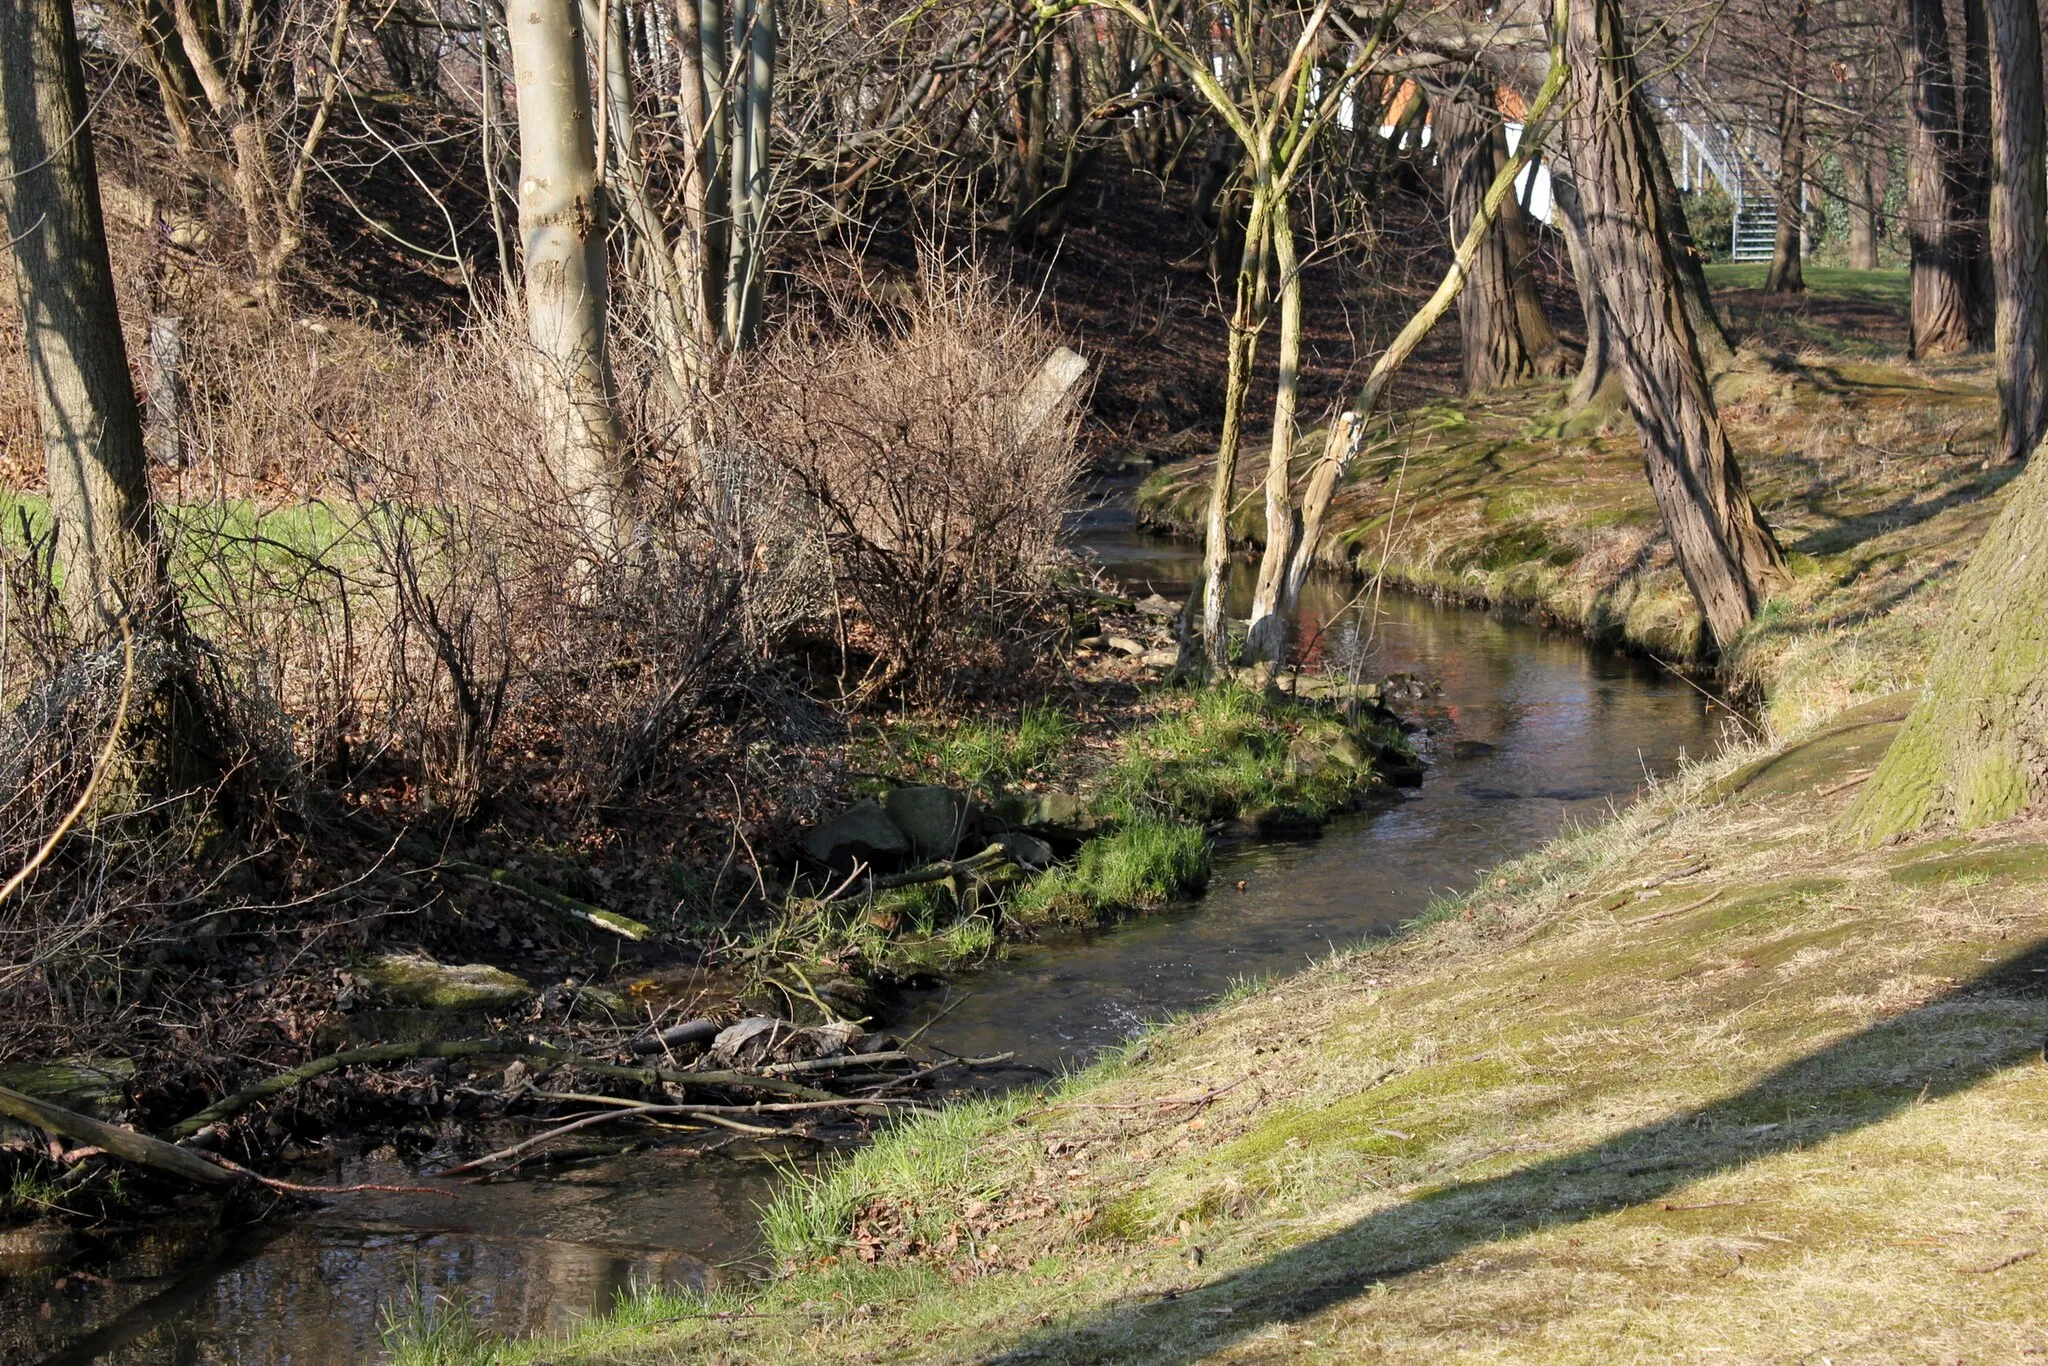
1565, 0, 1786, 647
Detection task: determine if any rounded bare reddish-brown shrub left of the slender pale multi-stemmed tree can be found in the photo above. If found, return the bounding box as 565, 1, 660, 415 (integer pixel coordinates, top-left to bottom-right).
729, 258, 1079, 694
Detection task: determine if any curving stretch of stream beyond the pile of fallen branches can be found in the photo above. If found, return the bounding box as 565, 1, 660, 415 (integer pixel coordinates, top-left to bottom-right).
913, 497, 1729, 1067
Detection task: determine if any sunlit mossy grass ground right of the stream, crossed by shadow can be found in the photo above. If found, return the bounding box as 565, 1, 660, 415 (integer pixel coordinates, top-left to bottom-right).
479, 270, 2048, 1362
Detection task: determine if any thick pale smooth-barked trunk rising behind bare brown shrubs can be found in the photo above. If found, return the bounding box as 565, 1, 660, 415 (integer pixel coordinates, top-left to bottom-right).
506, 0, 625, 555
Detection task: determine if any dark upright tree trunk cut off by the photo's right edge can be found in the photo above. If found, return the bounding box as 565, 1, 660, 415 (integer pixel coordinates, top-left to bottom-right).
1991, 0, 2048, 461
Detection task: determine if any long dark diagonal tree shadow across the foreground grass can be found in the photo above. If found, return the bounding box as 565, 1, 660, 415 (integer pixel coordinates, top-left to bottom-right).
989, 940, 2048, 1362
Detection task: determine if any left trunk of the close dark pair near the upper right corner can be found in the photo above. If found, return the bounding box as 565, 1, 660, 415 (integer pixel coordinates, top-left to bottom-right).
1907, 0, 1970, 358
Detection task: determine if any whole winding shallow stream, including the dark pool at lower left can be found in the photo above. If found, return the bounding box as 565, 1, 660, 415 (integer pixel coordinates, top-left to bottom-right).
16, 491, 1726, 1366
